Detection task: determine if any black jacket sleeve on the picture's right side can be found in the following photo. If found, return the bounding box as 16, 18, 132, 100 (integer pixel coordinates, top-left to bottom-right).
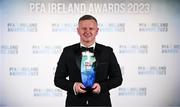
99, 48, 123, 93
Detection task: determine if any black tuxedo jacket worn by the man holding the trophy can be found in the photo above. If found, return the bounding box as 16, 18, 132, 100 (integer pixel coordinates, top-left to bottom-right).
54, 43, 122, 106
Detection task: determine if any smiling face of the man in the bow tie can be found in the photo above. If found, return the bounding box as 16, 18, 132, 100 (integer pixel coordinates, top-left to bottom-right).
77, 20, 99, 44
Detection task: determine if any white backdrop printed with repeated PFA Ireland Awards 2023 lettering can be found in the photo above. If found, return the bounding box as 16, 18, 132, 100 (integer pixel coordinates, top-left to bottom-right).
0, 0, 180, 107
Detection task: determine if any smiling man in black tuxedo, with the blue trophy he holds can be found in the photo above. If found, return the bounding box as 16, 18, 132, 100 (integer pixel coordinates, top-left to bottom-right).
54, 15, 123, 107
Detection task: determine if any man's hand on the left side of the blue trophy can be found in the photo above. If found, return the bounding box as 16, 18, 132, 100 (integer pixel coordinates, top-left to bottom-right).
74, 82, 86, 94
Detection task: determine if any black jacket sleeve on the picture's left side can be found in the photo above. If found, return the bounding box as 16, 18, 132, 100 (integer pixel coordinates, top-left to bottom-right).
54, 48, 74, 91
